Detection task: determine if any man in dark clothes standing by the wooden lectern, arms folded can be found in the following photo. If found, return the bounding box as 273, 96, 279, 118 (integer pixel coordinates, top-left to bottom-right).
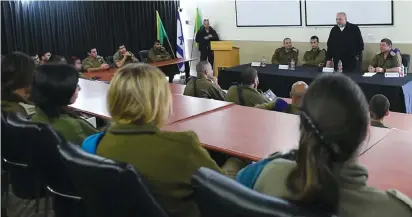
196, 19, 219, 67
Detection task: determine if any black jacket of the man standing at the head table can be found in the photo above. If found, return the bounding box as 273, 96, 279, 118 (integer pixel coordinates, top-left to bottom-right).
326, 22, 364, 61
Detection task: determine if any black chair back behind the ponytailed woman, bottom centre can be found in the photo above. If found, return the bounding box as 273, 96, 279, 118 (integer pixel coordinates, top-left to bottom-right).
192, 168, 330, 217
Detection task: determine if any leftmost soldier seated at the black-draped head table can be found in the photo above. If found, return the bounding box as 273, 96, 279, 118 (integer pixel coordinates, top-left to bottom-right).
272, 38, 299, 65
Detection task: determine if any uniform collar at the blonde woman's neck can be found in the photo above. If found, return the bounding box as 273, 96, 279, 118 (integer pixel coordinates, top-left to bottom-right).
108, 123, 160, 134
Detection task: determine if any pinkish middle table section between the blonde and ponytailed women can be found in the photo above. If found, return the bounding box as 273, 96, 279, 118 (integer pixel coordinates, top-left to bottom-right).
163, 105, 392, 161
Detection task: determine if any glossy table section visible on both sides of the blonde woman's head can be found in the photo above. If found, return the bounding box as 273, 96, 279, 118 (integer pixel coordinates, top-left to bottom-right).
69, 79, 234, 124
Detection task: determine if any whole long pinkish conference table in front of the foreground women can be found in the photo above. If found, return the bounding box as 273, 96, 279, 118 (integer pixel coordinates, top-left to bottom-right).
70, 79, 412, 196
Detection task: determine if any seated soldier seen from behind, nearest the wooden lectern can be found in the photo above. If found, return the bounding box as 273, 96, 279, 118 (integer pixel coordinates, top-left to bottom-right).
183, 61, 226, 101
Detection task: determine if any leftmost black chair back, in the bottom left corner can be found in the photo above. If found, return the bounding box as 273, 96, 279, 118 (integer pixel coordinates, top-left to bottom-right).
2, 113, 84, 217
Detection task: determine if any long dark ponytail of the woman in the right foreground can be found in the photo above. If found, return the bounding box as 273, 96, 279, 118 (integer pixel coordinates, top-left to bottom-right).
287, 112, 339, 214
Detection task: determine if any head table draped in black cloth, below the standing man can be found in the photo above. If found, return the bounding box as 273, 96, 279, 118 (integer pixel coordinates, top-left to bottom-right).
219, 64, 412, 114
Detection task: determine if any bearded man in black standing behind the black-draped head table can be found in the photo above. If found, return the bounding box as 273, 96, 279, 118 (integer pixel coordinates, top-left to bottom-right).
326, 12, 364, 72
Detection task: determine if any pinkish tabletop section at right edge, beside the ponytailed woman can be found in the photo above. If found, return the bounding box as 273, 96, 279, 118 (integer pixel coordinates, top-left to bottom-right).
359, 130, 412, 197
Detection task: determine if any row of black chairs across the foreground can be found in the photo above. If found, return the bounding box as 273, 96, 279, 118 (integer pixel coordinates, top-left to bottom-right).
1, 111, 328, 217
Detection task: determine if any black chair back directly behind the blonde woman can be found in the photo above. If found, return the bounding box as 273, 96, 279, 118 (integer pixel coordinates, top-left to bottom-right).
60, 139, 167, 217
